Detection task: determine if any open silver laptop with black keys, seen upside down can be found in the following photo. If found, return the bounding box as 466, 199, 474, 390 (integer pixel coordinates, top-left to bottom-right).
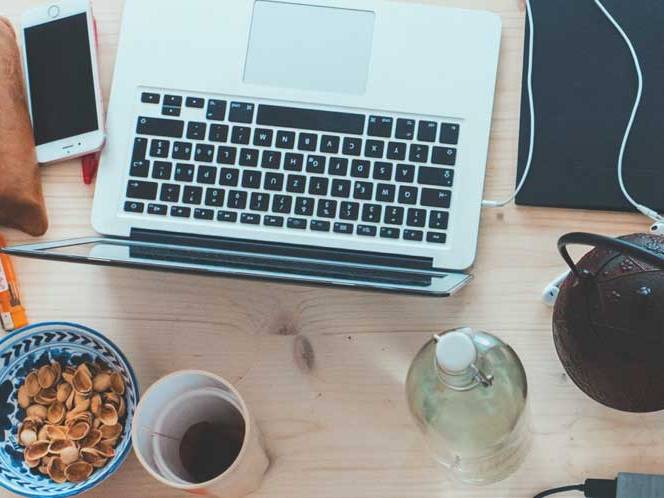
7, 0, 501, 296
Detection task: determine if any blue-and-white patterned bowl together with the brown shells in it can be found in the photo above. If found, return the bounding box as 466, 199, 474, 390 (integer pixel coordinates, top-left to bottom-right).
0, 322, 138, 498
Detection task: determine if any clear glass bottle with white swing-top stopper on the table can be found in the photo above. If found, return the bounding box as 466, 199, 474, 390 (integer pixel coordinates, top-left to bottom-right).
406, 328, 530, 485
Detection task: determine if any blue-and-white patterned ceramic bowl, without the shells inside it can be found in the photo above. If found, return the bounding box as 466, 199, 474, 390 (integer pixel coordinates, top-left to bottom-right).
0, 322, 138, 498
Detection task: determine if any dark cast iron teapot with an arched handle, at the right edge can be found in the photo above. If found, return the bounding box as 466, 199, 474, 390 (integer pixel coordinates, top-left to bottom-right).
553, 233, 664, 412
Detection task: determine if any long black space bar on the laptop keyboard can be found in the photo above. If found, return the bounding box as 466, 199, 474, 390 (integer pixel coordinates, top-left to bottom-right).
256, 104, 365, 135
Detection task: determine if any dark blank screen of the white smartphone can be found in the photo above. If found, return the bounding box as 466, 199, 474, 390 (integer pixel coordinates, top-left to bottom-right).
25, 13, 98, 145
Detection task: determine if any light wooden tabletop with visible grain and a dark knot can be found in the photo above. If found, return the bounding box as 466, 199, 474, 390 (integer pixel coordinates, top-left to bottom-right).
0, 0, 664, 498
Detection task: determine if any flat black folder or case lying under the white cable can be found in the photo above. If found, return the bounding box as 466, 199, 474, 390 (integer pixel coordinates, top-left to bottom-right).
517, 0, 664, 212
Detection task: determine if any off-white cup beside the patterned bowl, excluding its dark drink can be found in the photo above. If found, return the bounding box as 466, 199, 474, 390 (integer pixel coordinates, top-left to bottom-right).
132, 370, 269, 498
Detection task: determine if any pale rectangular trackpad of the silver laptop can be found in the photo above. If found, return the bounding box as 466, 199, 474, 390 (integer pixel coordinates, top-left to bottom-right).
244, 0, 376, 94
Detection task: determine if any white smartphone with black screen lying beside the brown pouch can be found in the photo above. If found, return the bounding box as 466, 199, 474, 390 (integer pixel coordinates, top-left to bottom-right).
21, 0, 104, 163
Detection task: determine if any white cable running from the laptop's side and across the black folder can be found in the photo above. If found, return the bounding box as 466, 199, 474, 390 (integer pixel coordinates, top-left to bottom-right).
482, 0, 664, 233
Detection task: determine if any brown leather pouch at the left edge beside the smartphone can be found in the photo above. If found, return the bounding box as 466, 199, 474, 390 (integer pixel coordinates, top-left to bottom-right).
0, 17, 48, 236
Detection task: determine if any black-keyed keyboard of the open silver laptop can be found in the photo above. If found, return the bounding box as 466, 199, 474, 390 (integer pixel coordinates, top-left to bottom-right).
123, 91, 460, 244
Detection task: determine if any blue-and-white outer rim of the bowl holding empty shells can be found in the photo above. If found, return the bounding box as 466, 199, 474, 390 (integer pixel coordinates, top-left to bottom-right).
0, 322, 140, 498
